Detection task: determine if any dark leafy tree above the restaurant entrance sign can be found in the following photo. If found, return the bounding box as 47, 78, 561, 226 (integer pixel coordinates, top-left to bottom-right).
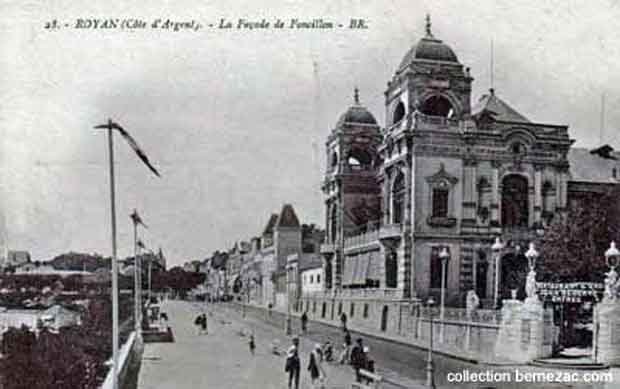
537, 187, 620, 282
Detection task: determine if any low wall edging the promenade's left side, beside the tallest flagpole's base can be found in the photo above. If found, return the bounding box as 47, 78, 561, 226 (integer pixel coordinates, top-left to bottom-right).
100, 332, 144, 389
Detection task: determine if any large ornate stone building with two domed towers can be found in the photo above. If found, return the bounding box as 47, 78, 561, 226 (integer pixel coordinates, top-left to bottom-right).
303, 17, 620, 330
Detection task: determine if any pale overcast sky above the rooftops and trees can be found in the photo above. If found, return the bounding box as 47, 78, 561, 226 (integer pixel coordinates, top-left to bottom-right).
0, 0, 620, 264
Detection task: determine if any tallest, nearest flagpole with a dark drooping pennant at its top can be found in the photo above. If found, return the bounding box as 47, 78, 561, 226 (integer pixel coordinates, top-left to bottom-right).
94, 119, 159, 389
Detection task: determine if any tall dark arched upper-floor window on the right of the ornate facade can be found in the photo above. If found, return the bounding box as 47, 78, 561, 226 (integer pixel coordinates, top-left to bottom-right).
501, 174, 529, 227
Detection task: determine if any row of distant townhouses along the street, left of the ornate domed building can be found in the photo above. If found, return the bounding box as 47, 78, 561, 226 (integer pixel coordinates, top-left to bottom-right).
200, 204, 324, 309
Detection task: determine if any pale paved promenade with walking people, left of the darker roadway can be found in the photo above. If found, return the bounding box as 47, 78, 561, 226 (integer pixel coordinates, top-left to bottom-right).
138, 301, 376, 389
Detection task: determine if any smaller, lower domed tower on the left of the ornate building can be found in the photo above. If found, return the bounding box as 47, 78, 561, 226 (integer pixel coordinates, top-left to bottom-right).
322, 88, 382, 289
